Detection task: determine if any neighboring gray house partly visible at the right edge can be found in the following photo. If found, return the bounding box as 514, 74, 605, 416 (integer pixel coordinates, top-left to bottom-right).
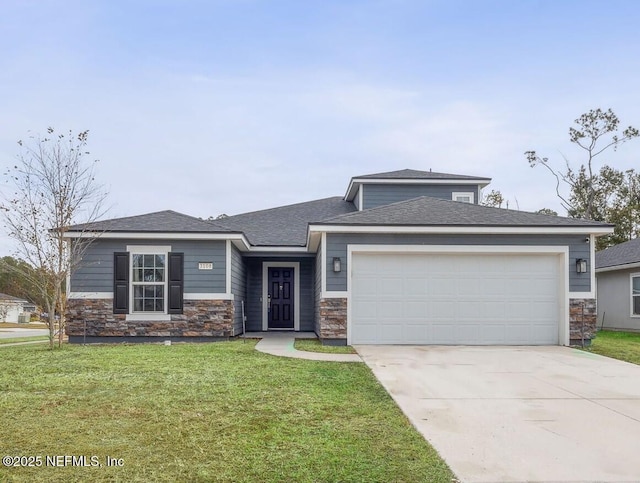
596, 238, 640, 331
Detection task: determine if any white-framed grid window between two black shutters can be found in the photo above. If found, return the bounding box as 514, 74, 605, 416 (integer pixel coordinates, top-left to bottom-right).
131, 254, 167, 313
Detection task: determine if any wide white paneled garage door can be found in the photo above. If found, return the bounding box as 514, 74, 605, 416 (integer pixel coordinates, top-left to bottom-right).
349, 253, 560, 345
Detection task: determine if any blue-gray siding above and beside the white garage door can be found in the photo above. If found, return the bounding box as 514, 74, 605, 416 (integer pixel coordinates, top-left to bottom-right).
325, 233, 593, 292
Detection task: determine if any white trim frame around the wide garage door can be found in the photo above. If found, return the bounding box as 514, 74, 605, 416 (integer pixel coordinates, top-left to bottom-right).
347, 245, 569, 346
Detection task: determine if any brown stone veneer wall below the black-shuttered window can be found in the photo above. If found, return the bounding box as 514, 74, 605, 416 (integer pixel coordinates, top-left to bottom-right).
67, 299, 235, 338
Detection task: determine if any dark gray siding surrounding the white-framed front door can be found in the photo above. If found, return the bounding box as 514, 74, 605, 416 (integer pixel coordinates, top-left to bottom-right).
245, 257, 315, 332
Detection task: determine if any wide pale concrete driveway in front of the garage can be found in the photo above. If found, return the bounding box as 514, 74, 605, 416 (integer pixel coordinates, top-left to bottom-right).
356, 346, 640, 482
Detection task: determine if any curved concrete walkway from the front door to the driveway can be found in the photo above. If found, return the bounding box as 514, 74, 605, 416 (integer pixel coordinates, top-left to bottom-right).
245, 332, 362, 362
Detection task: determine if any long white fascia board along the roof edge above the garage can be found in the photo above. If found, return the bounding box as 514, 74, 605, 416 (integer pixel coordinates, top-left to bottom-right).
309, 225, 613, 235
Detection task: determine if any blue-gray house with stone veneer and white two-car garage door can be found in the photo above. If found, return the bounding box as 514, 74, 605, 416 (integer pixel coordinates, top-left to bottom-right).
66, 169, 613, 345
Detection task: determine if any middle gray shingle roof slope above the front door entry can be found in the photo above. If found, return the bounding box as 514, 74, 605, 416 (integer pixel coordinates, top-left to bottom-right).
216, 196, 356, 246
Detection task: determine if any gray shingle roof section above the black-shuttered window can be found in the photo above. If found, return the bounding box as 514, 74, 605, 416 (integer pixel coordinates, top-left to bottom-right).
68, 210, 232, 233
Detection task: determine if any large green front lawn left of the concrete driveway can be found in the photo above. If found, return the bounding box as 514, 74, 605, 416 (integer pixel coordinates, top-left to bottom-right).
0, 341, 453, 482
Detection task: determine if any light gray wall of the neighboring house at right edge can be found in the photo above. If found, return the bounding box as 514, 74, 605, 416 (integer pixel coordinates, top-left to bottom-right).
596, 268, 640, 331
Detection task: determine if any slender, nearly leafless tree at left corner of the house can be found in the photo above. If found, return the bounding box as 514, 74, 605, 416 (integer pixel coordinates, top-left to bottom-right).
1, 128, 106, 348
